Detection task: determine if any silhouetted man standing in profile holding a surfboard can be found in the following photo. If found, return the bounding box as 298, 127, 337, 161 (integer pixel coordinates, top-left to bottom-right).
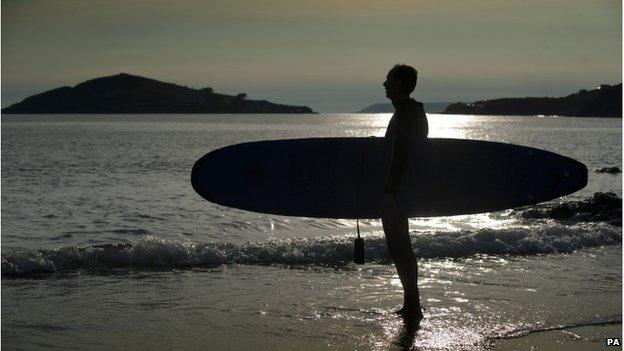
379, 64, 429, 319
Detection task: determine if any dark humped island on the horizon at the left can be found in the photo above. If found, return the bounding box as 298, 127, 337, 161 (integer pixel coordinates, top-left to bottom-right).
2, 73, 315, 113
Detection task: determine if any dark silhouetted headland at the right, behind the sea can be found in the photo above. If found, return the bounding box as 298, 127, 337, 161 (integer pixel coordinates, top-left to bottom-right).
444, 83, 622, 118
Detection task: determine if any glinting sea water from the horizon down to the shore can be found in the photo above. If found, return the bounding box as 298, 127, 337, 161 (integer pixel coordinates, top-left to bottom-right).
1, 114, 622, 350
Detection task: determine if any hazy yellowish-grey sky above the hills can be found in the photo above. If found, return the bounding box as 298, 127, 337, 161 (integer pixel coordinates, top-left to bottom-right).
1, 0, 622, 112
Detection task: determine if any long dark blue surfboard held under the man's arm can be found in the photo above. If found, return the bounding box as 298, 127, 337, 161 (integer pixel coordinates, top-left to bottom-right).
191, 137, 587, 218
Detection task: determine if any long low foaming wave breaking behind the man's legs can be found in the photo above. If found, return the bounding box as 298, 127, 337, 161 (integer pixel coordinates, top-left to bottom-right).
2, 224, 622, 277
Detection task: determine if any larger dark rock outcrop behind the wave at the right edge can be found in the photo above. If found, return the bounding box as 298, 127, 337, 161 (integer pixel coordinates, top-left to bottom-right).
513, 192, 622, 226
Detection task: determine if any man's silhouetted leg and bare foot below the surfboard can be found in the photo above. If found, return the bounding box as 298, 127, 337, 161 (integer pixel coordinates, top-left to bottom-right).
381, 217, 422, 318
